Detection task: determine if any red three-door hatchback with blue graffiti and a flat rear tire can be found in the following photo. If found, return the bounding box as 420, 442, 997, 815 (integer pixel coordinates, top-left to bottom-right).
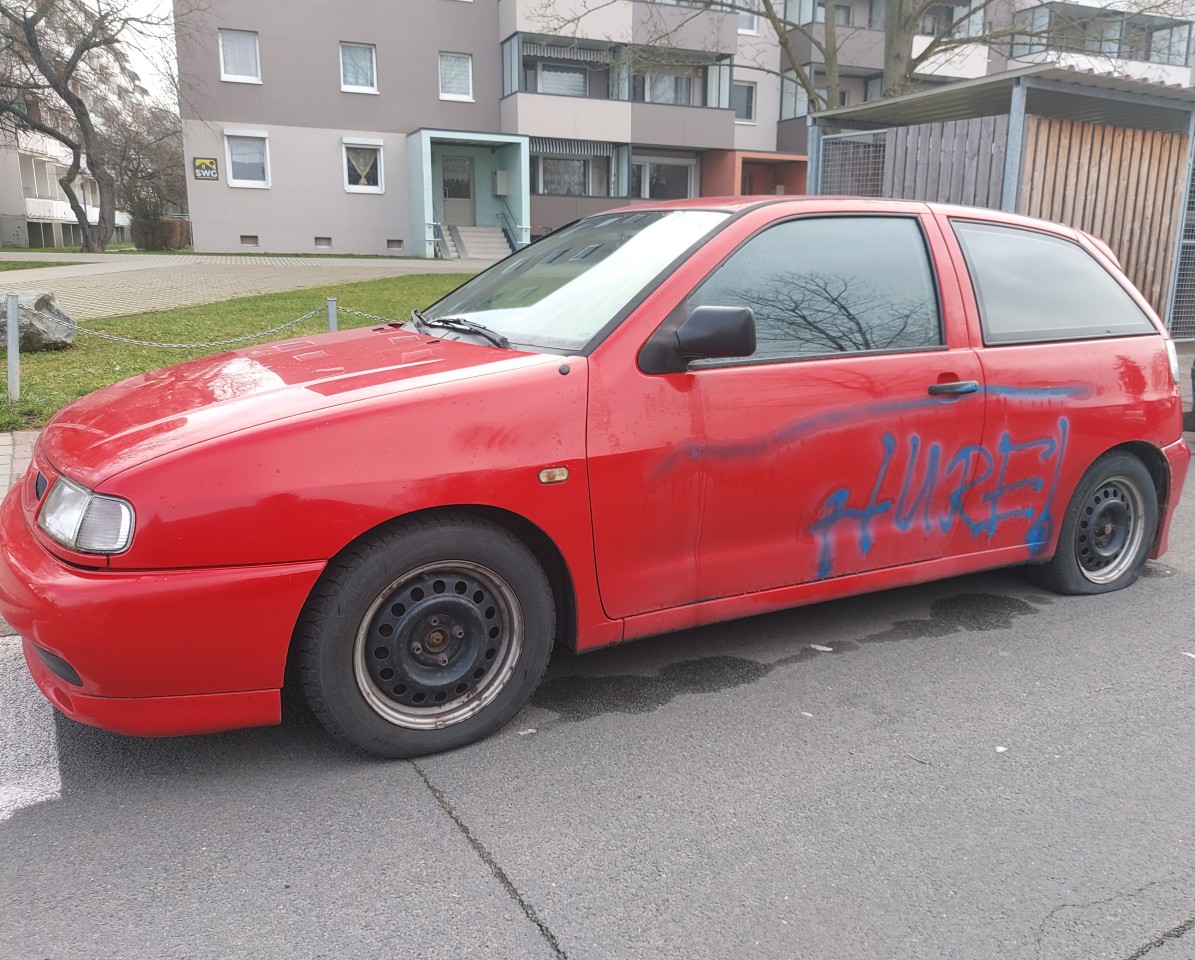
0, 197, 1190, 757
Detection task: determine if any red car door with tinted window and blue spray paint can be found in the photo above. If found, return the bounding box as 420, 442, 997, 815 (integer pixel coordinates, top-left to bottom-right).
588, 208, 983, 617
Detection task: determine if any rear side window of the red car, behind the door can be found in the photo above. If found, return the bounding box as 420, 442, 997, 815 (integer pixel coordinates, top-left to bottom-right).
952, 220, 1157, 343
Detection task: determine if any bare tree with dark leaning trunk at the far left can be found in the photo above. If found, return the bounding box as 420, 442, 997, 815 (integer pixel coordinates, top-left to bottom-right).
0, 0, 170, 251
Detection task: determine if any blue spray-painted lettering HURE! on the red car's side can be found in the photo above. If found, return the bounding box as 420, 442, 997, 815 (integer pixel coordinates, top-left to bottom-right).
810, 417, 1070, 577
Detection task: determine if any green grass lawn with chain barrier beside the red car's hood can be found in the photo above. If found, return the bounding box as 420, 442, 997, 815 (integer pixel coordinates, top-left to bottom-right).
0, 274, 468, 430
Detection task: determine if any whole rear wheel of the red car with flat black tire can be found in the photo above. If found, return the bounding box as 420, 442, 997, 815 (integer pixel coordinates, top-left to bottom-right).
1027, 453, 1158, 595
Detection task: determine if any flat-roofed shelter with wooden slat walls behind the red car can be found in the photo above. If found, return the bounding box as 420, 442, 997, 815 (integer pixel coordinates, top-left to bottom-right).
809, 63, 1195, 337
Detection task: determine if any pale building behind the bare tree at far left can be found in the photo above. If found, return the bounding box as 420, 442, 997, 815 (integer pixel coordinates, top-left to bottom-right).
0, 127, 129, 247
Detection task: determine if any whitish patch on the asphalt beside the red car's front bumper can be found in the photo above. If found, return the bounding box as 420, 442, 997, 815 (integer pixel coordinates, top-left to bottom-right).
0, 637, 62, 824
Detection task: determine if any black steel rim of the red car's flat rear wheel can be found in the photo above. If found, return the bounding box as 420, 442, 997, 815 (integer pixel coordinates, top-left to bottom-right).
1074, 477, 1145, 583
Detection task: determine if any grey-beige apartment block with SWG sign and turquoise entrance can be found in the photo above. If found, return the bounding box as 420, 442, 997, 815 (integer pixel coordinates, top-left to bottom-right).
177, 0, 804, 257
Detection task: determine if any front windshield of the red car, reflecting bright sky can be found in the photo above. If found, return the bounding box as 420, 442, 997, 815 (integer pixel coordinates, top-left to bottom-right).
423, 210, 730, 350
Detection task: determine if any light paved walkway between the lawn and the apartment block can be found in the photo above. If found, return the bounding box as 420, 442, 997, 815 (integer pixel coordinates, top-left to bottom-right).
0, 251, 490, 320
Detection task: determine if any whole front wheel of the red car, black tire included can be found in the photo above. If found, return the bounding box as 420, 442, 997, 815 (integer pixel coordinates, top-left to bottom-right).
295, 516, 556, 757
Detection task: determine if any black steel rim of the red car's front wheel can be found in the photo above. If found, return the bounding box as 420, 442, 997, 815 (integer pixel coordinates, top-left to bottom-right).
353, 561, 523, 730
